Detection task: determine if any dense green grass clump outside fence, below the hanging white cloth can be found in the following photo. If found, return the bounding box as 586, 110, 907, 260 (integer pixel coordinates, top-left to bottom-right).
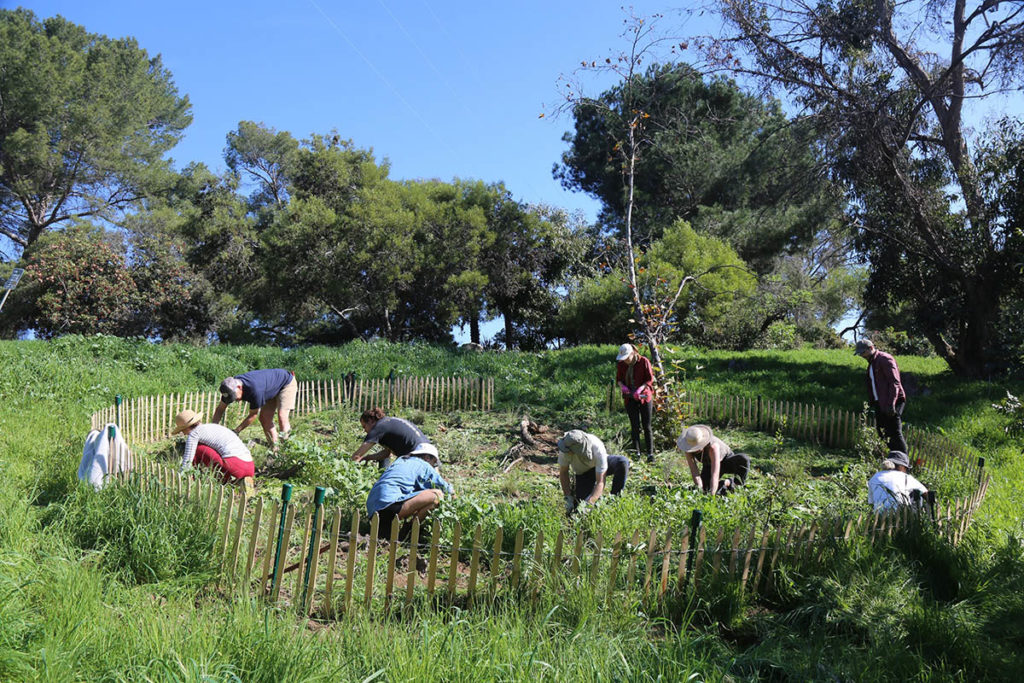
59, 484, 217, 585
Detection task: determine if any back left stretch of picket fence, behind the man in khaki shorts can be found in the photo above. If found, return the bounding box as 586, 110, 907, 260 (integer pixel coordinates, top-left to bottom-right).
92, 377, 495, 443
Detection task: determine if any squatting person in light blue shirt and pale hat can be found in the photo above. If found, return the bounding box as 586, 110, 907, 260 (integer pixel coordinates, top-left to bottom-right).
367, 443, 454, 538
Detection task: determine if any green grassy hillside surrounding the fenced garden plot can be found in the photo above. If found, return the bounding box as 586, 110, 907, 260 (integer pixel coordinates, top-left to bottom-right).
0, 337, 1024, 681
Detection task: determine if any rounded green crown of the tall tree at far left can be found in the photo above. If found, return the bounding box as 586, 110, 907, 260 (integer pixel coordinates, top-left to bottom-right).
0, 9, 191, 254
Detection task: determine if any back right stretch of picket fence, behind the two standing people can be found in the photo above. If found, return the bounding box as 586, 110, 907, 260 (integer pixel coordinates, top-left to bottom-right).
605, 383, 984, 478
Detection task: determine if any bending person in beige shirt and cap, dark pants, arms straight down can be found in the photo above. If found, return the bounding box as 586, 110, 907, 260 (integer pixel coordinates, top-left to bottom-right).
558, 429, 630, 514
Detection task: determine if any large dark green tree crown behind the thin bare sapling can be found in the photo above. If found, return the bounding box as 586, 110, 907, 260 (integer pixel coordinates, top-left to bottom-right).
555, 63, 837, 269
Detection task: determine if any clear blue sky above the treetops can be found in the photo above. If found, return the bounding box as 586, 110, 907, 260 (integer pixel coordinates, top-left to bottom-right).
16, 0, 704, 217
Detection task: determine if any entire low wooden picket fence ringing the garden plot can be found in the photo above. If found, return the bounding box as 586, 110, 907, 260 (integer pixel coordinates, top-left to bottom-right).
92, 378, 990, 617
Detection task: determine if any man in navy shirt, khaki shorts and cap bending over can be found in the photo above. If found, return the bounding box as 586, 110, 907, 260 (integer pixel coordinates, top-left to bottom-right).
211, 369, 299, 451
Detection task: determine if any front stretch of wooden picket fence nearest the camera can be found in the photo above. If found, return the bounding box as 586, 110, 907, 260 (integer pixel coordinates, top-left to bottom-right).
101, 459, 988, 617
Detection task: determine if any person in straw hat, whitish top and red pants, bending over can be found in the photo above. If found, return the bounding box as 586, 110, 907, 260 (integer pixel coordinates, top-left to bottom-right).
171, 411, 255, 493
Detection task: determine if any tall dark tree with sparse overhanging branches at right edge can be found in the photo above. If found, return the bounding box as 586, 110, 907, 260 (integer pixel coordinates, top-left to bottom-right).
703, 0, 1024, 376
